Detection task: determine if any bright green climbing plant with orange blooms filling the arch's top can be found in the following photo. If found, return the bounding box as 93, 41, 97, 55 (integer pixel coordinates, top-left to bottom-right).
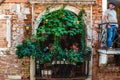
37, 9, 85, 48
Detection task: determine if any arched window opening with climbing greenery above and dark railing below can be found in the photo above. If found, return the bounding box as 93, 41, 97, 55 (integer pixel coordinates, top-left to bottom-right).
36, 9, 89, 78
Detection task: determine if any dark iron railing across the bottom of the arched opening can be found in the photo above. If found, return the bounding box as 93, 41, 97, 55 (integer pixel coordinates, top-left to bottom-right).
35, 59, 90, 79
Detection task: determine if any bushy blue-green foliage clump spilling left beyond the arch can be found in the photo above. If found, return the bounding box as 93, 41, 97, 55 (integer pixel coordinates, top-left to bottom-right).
16, 40, 41, 59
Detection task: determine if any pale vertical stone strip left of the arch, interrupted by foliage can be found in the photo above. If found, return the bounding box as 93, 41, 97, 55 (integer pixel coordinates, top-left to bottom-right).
30, 3, 35, 80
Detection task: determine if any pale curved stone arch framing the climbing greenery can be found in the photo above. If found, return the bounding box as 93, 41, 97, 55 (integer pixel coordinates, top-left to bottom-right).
33, 5, 92, 40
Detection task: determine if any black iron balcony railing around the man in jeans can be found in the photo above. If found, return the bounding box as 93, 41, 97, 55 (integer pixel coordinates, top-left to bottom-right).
98, 22, 120, 49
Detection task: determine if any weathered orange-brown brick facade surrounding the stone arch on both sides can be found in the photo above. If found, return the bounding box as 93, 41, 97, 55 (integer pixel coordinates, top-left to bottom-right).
0, 0, 120, 80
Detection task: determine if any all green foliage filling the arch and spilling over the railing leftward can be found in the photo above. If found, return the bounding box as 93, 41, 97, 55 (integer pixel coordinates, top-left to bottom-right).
16, 8, 90, 64
